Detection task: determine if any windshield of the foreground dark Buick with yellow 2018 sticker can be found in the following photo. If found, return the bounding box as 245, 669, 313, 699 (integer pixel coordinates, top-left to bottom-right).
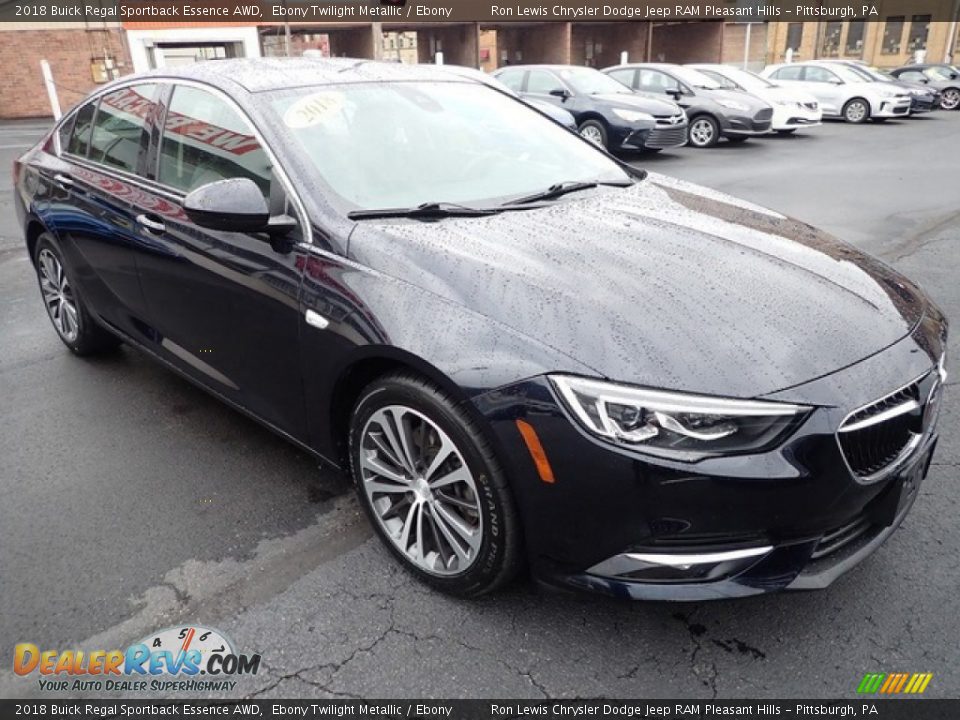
268, 81, 631, 210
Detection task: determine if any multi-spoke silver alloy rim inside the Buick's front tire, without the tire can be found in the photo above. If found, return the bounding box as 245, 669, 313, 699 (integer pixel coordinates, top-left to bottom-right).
357, 405, 483, 576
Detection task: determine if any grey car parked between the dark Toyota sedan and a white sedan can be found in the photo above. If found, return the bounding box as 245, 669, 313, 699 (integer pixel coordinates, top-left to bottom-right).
603, 63, 773, 147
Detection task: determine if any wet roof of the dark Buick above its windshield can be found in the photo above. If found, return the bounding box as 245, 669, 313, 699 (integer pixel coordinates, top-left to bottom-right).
132, 57, 468, 92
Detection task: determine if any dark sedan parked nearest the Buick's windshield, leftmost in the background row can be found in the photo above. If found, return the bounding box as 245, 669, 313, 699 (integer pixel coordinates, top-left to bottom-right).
493, 65, 687, 152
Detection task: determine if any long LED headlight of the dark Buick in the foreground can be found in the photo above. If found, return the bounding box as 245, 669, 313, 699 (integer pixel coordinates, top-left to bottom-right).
549, 375, 810, 461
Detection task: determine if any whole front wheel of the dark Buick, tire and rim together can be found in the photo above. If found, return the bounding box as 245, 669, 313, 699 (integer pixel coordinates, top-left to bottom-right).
349, 373, 522, 597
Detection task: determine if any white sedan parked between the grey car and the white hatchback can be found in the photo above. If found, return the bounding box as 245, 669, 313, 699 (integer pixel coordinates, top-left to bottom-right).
689, 63, 822, 135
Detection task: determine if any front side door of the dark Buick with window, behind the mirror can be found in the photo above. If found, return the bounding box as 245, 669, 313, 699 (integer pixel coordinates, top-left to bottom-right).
134, 83, 306, 440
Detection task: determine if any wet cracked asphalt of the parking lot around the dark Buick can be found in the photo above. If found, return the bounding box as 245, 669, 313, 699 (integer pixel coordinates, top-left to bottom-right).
0, 112, 960, 698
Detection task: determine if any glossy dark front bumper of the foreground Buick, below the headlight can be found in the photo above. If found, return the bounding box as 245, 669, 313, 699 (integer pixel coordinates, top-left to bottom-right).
474, 312, 941, 600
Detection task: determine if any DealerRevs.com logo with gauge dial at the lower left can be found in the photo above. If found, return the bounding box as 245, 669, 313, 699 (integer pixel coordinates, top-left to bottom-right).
13, 626, 260, 692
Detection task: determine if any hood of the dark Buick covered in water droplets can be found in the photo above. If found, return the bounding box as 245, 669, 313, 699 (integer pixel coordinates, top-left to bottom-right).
350, 174, 925, 397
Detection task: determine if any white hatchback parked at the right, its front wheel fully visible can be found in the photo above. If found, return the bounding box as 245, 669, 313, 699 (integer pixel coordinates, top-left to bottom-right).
761, 61, 910, 123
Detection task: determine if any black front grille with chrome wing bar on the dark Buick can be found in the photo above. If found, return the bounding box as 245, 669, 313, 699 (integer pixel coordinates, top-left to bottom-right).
837, 381, 923, 479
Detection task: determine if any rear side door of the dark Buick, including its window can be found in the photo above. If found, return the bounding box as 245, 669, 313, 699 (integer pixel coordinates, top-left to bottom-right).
51, 83, 158, 335
